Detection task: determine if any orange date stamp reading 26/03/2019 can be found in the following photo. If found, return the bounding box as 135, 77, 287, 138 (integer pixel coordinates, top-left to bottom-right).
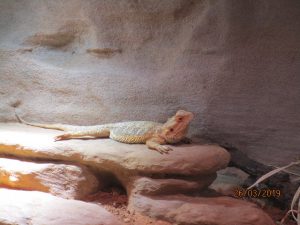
234, 187, 282, 198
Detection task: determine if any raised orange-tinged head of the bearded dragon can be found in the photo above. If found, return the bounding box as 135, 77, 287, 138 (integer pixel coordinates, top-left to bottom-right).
160, 110, 194, 143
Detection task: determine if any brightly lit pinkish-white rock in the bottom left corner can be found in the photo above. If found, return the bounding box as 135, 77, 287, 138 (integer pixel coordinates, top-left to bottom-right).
0, 188, 122, 225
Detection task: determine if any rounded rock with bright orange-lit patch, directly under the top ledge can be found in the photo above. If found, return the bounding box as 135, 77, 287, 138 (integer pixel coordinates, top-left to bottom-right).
0, 158, 98, 199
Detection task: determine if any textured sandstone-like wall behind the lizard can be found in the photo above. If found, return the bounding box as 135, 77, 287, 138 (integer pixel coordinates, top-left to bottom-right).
0, 0, 300, 164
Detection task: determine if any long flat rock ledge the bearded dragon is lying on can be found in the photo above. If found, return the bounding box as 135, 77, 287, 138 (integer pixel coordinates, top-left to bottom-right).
0, 123, 230, 187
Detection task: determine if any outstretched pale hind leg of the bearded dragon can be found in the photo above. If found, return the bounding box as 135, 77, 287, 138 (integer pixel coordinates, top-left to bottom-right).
55, 127, 110, 141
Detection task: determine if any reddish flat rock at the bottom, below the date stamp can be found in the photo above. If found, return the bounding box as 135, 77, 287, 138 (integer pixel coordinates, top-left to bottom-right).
129, 195, 275, 225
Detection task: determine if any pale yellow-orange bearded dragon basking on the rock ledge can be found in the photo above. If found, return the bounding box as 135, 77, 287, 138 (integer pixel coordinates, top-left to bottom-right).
15, 110, 194, 154
